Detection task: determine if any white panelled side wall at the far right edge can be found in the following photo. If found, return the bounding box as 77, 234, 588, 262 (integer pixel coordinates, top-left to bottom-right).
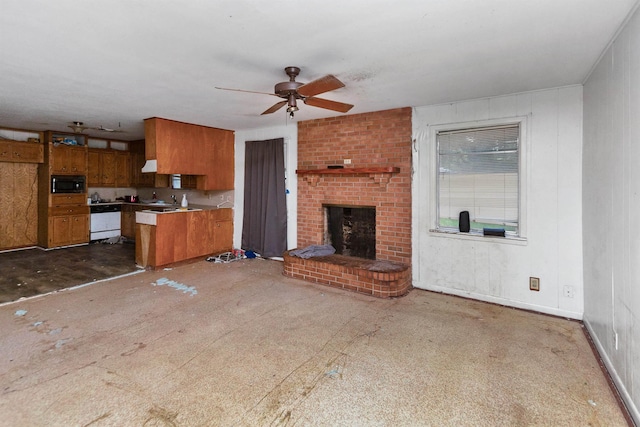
583, 4, 640, 425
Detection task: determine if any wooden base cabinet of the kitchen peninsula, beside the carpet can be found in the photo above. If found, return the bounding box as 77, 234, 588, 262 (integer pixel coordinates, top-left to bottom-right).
136, 209, 233, 267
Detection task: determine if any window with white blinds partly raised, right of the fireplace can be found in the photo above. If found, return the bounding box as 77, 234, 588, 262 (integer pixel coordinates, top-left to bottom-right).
436, 123, 521, 236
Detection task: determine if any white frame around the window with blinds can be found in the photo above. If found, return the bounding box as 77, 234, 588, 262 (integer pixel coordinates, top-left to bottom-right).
428, 116, 530, 240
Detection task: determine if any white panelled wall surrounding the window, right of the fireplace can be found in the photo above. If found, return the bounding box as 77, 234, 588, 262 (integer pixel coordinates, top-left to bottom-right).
412, 86, 583, 319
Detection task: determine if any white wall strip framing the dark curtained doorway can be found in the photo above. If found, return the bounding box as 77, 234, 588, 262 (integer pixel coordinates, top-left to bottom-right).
233, 122, 298, 249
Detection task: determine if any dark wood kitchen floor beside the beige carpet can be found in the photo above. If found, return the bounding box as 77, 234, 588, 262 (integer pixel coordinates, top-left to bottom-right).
0, 242, 138, 303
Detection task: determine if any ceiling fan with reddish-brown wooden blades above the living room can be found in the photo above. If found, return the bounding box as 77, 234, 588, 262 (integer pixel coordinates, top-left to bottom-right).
216, 67, 353, 118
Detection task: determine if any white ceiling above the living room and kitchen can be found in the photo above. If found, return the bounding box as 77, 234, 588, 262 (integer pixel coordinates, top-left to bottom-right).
0, 0, 637, 140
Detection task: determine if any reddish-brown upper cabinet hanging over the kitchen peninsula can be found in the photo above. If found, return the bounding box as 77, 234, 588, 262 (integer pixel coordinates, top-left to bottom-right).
144, 117, 234, 190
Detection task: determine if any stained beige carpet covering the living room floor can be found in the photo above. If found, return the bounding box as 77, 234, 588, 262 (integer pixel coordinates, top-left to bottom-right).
0, 259, 625, 426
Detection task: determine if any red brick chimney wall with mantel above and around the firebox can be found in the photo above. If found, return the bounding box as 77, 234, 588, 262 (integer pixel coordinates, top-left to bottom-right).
298, 108, 411, 265
